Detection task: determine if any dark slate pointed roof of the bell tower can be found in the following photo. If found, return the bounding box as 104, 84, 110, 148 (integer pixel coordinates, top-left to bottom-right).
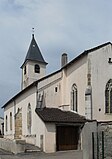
21, 34, 47, 68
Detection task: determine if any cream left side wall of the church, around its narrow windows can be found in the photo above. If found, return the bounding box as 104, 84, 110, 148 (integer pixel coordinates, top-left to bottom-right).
4, 87, 36, 143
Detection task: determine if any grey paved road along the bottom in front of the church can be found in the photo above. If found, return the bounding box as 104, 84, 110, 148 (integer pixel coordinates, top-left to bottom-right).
0, 149, 82, 159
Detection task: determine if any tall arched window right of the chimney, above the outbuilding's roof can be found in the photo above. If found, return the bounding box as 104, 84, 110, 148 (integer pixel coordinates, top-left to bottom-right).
71, 84, 77, 111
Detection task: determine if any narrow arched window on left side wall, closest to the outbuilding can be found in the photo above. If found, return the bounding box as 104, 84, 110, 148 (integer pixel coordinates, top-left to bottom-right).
27, 103, 32, 133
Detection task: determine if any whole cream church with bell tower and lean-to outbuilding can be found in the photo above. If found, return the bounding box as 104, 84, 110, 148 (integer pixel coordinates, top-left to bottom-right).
2, 34, 112, 152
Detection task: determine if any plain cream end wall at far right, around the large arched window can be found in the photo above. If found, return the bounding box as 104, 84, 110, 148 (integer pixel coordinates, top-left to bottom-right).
89, 45, 112, 121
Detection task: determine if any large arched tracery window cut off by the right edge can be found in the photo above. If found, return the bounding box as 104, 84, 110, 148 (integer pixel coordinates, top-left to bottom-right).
105, 79, 112, 113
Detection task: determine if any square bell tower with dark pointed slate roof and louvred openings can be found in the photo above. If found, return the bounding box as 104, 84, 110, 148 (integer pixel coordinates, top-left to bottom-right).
21, 34, 47, 90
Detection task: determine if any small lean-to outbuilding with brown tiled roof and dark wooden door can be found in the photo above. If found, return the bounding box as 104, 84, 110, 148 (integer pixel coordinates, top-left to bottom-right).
35, 108, 87, 152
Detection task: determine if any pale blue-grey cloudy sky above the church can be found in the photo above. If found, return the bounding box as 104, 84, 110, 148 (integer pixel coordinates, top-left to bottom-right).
0, 0, 112, 116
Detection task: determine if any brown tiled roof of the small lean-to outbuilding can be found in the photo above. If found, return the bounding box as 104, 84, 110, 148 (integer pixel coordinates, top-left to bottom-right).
35, 108, 86, 123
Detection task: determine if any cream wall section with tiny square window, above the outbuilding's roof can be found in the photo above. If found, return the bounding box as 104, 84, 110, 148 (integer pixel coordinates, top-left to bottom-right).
38, 72, 62, 107
